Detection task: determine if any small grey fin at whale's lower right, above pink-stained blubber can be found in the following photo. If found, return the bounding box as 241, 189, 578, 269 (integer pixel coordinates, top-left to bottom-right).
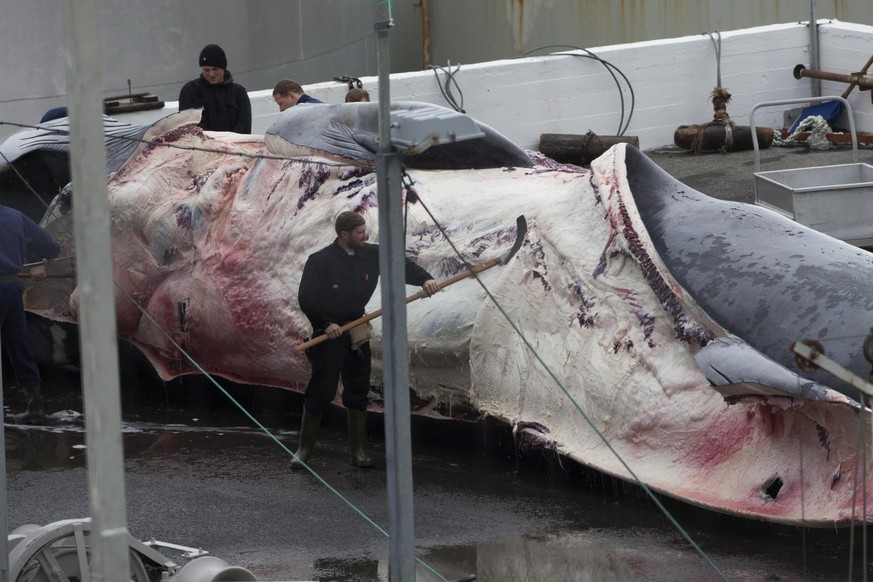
694, 336, 861, 410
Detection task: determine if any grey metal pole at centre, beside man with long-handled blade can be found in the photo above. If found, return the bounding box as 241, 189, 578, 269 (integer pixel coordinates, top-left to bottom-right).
375, 22, 415, 582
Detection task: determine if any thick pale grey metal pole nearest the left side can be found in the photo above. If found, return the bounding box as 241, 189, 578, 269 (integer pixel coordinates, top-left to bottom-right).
64, 0, 130, 582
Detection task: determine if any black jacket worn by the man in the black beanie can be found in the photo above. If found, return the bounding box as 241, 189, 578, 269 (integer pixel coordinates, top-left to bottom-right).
179, 71, 252, 133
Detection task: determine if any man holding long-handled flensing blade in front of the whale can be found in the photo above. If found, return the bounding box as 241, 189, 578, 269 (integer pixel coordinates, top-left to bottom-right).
291, 212, 440, 468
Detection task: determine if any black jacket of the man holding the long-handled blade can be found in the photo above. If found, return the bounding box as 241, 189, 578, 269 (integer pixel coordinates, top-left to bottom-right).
297, 240, 433, 330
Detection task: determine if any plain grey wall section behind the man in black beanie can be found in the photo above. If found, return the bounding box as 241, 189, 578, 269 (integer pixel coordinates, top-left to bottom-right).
0, 0, 384, 139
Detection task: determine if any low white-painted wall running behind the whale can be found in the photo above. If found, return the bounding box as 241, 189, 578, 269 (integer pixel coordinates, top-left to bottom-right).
109, 21, 873, 149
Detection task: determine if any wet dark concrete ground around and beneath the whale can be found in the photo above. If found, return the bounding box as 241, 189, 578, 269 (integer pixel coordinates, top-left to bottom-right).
5, 143, 873, 581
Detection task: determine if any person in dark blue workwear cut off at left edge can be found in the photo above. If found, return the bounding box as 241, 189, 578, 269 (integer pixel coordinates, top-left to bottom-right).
0, 206, 60, 423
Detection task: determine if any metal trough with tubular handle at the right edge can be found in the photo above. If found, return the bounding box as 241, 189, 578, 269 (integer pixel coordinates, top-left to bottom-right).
750, 96, 873, 246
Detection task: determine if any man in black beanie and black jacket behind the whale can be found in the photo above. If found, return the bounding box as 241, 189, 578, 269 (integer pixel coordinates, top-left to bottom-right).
179, 44, 252, 133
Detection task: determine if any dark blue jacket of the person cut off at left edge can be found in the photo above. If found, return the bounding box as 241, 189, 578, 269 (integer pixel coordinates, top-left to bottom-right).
0, 206, 61, 275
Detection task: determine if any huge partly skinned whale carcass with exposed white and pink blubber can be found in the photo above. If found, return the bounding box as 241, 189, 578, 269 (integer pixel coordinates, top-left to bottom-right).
10, 103, 873, 526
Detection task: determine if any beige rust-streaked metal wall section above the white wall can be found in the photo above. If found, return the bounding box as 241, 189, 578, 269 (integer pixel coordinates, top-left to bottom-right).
392, 0, 873, 71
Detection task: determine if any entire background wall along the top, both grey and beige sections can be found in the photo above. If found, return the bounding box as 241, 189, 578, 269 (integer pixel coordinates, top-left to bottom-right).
0, 0, 873, 139
